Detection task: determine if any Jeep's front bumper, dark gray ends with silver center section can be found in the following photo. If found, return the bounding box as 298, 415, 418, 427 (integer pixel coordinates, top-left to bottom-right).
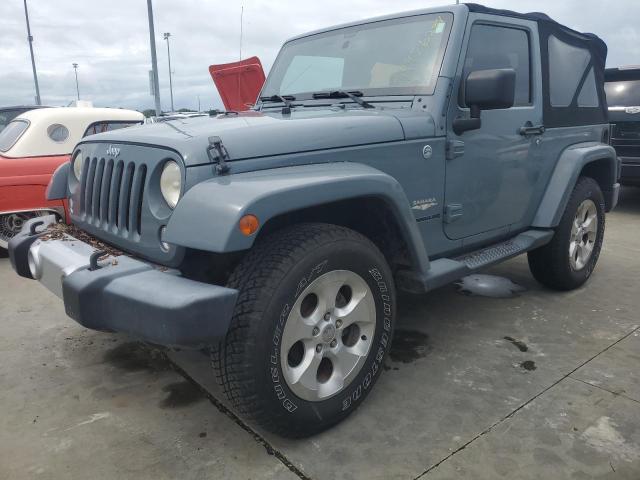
9, 217, 238, 347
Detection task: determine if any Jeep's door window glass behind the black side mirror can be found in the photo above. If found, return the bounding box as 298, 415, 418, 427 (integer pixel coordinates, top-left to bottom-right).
459, 23, 531, 106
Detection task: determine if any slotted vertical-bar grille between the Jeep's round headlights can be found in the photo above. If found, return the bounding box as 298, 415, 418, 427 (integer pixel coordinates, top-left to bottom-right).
77, 157, 147, 238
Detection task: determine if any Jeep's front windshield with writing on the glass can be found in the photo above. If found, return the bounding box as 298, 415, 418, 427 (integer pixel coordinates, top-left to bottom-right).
261, 13, 453, 100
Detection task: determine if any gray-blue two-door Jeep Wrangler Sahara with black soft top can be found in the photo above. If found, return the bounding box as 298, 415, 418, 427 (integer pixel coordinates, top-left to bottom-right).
10, 4, 619, 437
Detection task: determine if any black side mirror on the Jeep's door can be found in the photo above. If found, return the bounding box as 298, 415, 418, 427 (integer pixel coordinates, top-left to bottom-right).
453, 68, 516, 135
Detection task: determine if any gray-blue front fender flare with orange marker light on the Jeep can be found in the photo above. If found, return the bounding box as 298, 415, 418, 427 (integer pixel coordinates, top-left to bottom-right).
163, 162, 429, 272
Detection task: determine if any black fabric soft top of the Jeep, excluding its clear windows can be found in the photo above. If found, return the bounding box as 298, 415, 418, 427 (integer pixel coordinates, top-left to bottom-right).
465, 3, 607, 127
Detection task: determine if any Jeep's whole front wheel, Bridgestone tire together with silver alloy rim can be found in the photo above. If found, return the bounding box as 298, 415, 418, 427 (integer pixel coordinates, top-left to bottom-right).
212, 224, 395, 437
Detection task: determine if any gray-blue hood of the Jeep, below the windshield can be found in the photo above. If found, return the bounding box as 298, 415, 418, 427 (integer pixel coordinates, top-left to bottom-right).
82, 109, 424, 166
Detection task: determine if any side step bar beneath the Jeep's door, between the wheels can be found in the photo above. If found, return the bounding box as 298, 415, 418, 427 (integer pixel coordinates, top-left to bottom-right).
397, 230, 554, 293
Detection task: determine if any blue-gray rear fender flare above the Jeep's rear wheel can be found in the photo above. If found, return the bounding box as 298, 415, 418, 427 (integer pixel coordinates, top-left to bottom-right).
532, 142, 618, 228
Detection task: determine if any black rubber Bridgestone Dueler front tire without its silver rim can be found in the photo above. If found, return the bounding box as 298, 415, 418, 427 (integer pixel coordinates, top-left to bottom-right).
212, 224, 395, 437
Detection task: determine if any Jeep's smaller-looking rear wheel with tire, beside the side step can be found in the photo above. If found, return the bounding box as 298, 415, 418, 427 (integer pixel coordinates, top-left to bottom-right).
528, 177, 605, 290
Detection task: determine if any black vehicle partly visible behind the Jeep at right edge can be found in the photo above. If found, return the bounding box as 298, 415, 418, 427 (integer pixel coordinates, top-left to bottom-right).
605, 66, 640, 186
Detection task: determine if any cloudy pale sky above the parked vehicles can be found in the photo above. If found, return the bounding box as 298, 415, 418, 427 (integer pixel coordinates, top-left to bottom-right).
0, 0, 640, 110
